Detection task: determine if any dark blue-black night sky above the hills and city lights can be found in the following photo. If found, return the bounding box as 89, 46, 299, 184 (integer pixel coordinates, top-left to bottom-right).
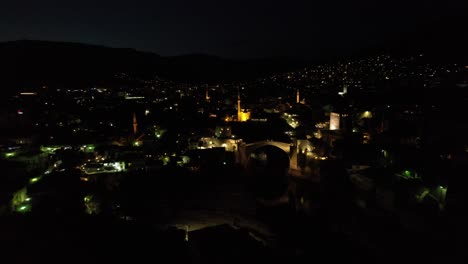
0, 0, 468, 58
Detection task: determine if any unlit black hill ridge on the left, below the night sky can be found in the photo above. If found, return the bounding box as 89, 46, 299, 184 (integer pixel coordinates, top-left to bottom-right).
0, 40, 306, 93
